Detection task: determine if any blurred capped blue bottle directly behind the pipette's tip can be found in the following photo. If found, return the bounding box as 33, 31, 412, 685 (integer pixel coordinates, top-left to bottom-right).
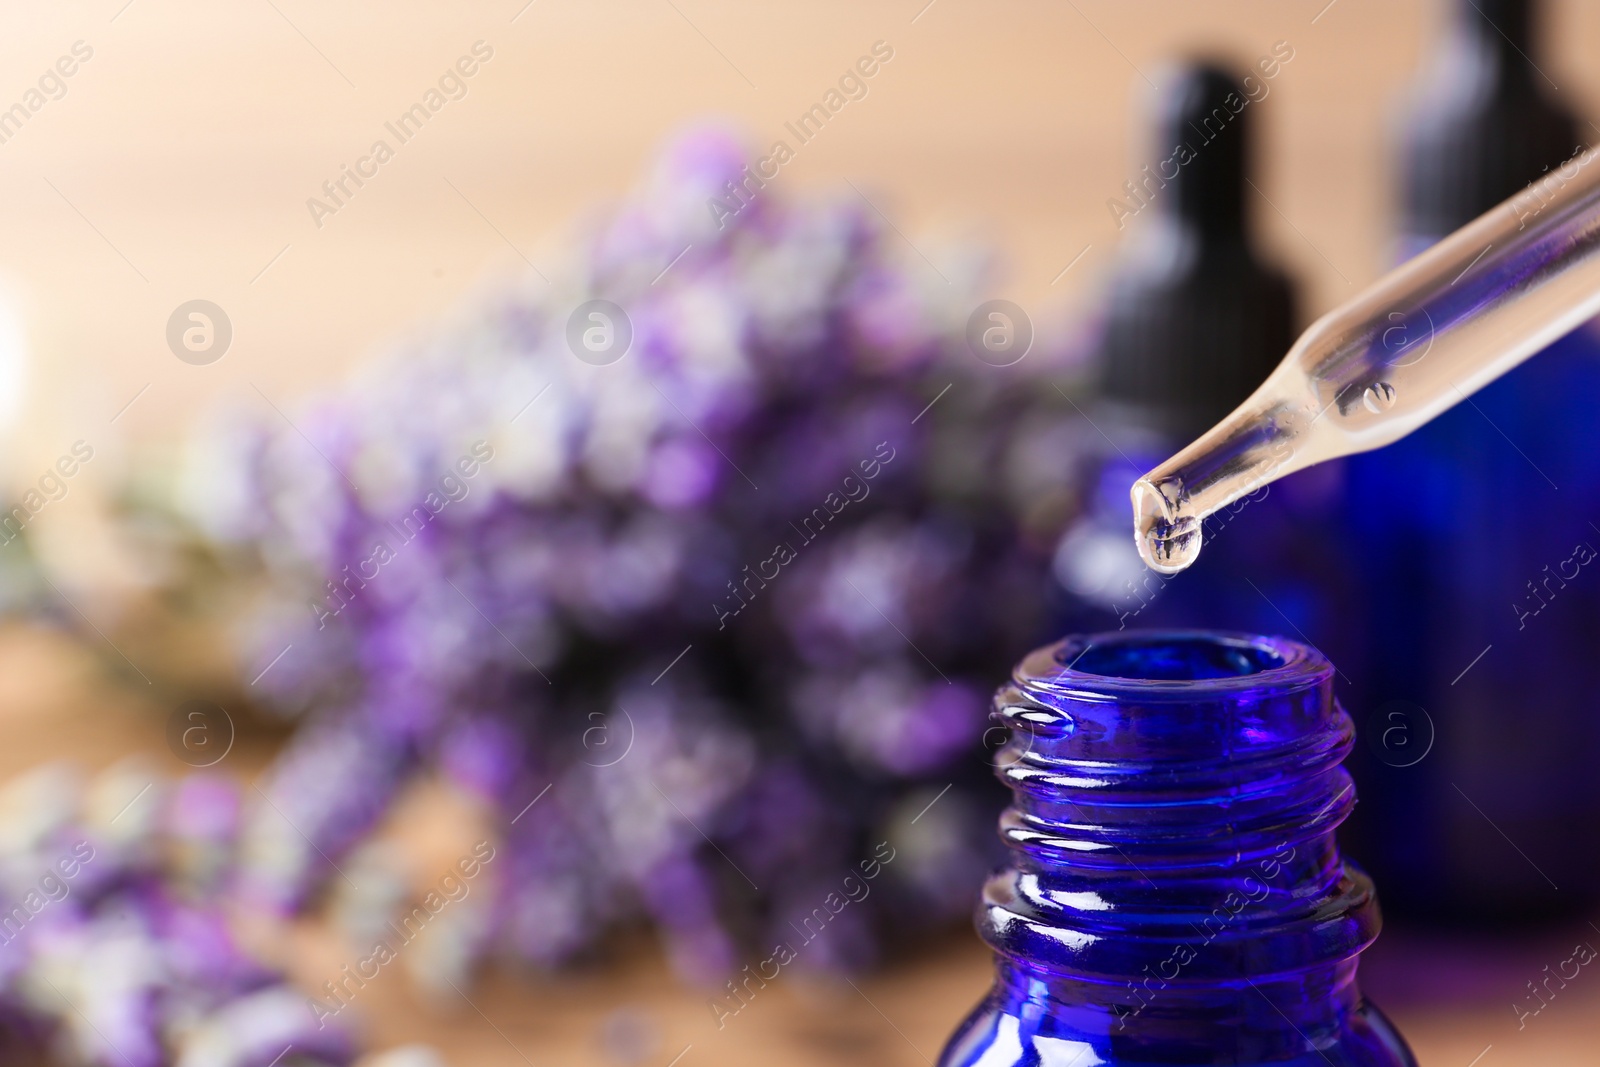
1053, 64, 1339, 651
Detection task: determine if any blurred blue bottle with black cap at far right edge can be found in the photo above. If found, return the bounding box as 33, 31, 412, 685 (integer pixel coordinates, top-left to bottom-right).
1346, 0, 1600, 925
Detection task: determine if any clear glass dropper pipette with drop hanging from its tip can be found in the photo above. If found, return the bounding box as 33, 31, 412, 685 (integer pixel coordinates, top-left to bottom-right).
1131, 149, 1600, 574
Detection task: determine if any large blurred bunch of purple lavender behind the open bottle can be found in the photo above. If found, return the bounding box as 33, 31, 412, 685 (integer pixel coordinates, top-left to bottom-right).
159, 131, 1075, 981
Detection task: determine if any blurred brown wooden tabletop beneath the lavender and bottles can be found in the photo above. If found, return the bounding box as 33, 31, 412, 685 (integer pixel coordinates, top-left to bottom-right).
0, 627, 1600, 1067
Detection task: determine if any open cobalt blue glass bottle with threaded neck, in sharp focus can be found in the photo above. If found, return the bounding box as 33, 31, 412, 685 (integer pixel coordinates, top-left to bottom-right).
941, 630, 1414, 1067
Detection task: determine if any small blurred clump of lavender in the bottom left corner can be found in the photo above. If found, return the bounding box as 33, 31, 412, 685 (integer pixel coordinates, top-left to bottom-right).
0, 763, 354, 1067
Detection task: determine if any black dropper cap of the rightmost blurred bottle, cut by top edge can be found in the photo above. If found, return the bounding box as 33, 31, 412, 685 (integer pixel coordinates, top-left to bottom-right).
1400, 0, 1578, 238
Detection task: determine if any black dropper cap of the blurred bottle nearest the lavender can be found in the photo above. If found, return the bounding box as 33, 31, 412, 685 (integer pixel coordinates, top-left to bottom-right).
1099, 64, 1296, 435
